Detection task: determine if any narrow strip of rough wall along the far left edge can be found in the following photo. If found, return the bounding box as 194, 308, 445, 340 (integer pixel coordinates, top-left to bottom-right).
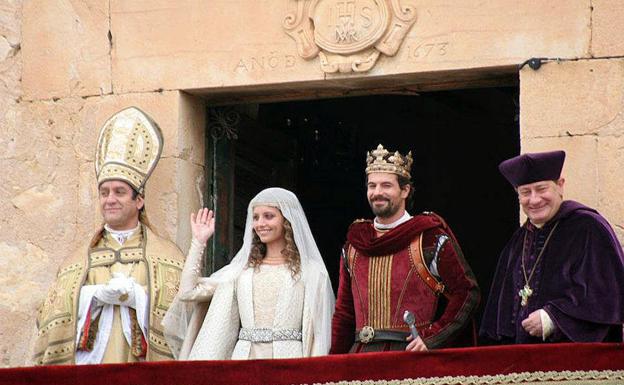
0, 0, 26, 366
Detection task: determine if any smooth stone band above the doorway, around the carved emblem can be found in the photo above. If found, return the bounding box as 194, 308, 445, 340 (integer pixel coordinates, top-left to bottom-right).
24, 0, 591, 99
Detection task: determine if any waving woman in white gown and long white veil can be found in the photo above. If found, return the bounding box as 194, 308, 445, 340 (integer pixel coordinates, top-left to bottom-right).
163, 188, 334, 360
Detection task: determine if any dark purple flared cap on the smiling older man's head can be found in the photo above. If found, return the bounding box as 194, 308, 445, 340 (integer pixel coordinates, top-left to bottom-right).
498, 151, 565, 187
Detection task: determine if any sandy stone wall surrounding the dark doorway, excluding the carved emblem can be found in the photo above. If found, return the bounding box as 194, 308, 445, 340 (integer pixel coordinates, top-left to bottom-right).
0, 0, 624, 366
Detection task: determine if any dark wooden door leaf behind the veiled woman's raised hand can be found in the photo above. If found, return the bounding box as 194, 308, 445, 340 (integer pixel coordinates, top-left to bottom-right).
206, 105, 297, 273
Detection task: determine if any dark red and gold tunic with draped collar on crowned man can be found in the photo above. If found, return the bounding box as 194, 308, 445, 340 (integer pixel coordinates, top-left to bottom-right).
330, 214, 480, 353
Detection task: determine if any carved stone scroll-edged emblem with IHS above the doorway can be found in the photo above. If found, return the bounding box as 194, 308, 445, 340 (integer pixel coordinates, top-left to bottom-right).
283, 0, 416, 72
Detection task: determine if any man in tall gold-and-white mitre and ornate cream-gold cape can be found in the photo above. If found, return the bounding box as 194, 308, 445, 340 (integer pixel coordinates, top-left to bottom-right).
33, 107, 184, 365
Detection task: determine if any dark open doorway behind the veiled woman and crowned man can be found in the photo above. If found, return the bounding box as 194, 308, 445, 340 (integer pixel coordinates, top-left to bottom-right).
208, 87, 520, 324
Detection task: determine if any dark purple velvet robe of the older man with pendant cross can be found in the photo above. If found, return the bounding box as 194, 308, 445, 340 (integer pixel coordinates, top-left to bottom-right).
480, 201, 624, 343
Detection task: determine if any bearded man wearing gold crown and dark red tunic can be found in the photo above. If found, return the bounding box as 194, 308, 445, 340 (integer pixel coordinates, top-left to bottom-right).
330, 144, 479, 353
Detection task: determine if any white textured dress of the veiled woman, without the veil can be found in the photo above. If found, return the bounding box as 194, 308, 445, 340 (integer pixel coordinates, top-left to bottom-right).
189, 264, 316, 360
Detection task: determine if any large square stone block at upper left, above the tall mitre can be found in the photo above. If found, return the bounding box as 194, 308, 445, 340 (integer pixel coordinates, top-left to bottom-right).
22, 0, 112, 99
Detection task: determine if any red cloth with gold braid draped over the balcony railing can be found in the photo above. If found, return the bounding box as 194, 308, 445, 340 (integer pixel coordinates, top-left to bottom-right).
0, 344, 624, 385
